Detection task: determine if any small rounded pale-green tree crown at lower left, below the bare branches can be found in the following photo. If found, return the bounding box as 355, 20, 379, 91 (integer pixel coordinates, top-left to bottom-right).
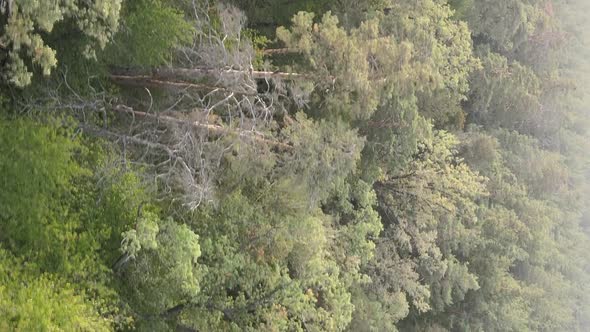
122, 217, 204, 314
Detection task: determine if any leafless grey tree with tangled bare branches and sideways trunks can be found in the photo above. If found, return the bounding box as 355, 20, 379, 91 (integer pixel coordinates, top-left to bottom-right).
24, 0, 301, 209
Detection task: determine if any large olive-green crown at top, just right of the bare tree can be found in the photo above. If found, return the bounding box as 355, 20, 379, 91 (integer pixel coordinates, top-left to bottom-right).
277, 0, 479, 120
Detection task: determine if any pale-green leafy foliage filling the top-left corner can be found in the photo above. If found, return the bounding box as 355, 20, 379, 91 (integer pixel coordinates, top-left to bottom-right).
0, 0, 121, 87
